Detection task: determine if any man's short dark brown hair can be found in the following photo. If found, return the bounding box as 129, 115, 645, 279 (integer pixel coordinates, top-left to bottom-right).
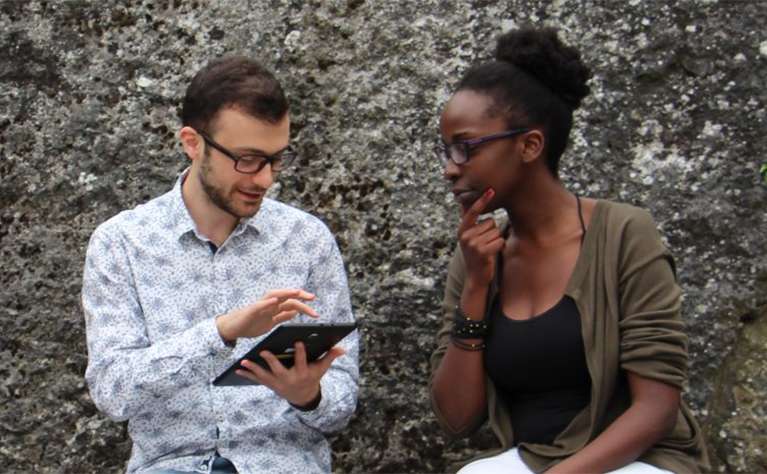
181, 56, 288, 133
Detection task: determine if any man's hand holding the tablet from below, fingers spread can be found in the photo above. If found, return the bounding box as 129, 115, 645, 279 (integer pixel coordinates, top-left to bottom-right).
236, 342, 345, 407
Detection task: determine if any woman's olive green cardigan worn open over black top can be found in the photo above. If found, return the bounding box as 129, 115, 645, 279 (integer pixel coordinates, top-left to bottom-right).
431, 201, 708, 473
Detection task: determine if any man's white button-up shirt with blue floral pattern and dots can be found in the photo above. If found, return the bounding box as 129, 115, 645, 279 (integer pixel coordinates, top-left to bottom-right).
82, 177, 359, 474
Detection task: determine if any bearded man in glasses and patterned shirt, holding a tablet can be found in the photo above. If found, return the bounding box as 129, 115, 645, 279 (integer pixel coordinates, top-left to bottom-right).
82, 57, 358, 473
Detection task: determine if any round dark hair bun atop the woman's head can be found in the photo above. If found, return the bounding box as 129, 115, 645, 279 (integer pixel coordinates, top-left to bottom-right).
495, 27, 591, 110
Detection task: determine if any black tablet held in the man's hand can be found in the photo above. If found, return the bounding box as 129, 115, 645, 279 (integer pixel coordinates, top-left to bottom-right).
213, 323, 357, 387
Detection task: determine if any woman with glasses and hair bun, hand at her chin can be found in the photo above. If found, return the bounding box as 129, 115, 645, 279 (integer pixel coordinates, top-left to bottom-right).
431, 29, 708, 474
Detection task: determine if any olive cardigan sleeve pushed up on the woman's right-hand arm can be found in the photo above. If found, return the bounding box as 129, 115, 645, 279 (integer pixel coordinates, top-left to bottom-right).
618, 209, 687, 389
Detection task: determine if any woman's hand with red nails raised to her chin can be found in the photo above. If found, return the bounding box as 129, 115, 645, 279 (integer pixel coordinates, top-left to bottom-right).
458, 188, 506, 287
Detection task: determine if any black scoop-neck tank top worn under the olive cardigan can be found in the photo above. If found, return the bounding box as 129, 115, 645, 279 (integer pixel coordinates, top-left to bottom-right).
484, 196, 591, 444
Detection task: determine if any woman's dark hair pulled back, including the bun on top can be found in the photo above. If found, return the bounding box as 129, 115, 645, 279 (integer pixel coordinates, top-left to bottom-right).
458, 28, 591, 177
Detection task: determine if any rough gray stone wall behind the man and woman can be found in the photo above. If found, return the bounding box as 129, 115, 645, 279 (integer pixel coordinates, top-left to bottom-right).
0, 0, 767, 473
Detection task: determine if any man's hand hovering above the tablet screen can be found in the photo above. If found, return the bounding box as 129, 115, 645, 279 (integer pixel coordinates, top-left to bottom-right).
216, 289, 318, 342
